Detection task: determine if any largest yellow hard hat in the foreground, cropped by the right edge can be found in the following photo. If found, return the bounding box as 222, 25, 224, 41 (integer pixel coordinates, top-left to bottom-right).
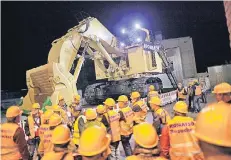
195, 102, 231, 147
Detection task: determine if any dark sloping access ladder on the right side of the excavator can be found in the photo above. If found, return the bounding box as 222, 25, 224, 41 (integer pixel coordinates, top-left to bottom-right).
157, 45, 177, 89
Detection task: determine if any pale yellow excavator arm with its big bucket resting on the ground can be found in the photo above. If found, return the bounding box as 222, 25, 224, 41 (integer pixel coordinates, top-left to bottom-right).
22, 17, 124, 110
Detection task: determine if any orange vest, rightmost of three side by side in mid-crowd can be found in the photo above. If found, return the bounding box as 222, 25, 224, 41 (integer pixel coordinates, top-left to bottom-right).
133, 100, 148, 123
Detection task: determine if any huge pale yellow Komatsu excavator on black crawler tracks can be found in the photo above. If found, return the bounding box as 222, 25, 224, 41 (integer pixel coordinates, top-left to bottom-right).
22, 17, 176, 110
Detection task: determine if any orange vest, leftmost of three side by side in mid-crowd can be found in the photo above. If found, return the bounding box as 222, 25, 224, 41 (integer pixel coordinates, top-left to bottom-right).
106, 110, 121, 142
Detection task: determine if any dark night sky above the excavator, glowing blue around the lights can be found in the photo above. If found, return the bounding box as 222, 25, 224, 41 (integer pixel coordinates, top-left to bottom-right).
1, 2, 231, 90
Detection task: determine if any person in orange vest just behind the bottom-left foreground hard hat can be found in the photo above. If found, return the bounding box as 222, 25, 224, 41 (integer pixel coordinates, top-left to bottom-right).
38, 113, 62, 157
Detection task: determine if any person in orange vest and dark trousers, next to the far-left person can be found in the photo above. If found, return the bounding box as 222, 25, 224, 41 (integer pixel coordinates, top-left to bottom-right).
25, 103, 42, 157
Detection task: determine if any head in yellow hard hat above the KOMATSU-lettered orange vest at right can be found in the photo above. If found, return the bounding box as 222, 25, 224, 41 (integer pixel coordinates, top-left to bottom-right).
173, 101, 188, 116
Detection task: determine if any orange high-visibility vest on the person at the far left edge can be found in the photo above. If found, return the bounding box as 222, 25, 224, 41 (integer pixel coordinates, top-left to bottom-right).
0, 123, 21, 160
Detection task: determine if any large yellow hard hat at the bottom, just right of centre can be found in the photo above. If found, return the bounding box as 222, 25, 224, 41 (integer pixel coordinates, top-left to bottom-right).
133, 122, 159, 148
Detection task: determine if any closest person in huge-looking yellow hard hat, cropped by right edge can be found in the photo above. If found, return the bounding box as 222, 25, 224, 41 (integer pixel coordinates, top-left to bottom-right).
195, 102, 231, 160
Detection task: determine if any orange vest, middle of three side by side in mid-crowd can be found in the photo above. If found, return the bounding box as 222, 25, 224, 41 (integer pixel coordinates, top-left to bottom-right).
120, 106, 134, 136
